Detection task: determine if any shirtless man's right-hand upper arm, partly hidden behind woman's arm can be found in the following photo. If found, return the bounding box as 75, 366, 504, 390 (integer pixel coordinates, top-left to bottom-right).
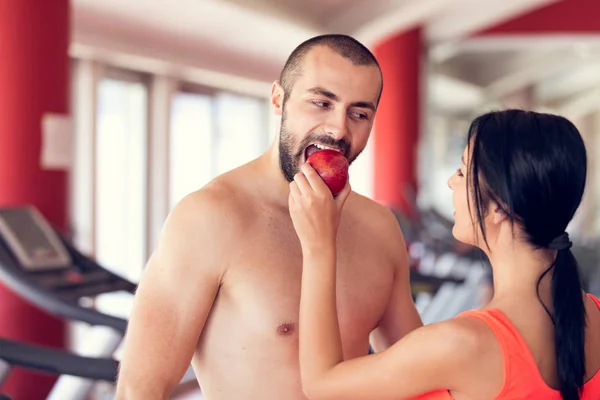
371, 210, 423, 351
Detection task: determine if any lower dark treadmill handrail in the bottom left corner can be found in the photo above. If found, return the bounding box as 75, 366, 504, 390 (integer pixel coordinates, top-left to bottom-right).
0, 339, 119, 382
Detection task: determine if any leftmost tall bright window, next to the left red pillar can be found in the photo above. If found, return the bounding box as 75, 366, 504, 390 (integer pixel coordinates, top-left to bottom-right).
95, 78, 148, 282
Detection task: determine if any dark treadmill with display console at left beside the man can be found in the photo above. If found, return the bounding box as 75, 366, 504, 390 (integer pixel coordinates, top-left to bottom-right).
0, 205, 195, 400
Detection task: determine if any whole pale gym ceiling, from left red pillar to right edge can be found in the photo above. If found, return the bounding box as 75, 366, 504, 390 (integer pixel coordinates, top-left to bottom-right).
71, 0, 600, 119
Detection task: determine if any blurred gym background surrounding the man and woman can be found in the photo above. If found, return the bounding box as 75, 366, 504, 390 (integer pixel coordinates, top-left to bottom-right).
0, 0, 600, 400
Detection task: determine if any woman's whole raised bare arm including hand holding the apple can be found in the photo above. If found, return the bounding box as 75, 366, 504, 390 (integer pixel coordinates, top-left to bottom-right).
290, 166, 479, 400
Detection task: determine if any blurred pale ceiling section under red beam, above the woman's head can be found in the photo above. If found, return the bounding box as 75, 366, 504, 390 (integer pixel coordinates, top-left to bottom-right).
431, 37, 600, 118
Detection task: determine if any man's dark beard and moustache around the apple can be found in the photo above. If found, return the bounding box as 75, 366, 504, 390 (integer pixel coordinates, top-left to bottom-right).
279, 107, 361, 182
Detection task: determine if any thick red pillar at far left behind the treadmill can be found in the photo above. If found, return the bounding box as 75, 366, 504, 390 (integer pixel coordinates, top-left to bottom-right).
0, 0, 70, 400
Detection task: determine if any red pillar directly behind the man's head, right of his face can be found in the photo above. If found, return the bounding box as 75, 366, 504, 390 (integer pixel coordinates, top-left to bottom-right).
373, 28, 422, 217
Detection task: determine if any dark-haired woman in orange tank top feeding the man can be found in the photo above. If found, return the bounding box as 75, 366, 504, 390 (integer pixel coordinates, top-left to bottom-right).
290, 110, 600, 400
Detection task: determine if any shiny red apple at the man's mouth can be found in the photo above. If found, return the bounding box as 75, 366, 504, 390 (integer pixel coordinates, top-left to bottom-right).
306, 150, 348, 196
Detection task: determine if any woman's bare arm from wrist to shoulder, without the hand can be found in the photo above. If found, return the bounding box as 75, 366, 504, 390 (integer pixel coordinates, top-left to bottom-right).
299, 248, 479, 400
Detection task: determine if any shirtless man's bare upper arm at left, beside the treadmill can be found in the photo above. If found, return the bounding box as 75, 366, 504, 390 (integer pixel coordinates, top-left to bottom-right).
117, 192, 231, 399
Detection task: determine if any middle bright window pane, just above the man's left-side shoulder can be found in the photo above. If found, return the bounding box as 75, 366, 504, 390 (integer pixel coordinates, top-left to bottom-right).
169, 93, 214, 208
